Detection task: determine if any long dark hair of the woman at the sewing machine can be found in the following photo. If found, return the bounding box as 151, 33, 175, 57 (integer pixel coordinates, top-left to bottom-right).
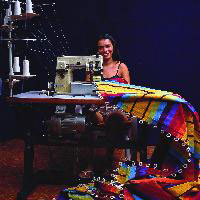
96, 33, 120, 61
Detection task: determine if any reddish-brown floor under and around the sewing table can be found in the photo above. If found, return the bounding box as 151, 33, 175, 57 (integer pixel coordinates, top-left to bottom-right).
0, 139, 156, 200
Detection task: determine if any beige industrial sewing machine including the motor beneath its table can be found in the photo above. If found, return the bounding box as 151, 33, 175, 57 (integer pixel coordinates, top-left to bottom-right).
40, 55, 103, 137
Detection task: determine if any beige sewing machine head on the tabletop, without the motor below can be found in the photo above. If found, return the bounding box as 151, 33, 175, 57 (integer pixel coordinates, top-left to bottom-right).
54, 55, 103, 93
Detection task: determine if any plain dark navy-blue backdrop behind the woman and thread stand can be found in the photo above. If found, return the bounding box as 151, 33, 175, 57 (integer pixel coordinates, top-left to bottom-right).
0, 0, 200, 139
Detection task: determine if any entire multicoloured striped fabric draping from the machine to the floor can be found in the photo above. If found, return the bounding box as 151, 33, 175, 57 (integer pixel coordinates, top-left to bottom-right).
59, 81, 200, 200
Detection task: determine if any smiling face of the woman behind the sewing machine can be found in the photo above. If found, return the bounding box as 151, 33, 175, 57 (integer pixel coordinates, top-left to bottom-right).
97, 39, 113, 60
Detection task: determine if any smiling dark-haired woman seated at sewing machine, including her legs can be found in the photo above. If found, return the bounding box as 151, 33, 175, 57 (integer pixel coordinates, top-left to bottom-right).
79, 34, 130, 178
